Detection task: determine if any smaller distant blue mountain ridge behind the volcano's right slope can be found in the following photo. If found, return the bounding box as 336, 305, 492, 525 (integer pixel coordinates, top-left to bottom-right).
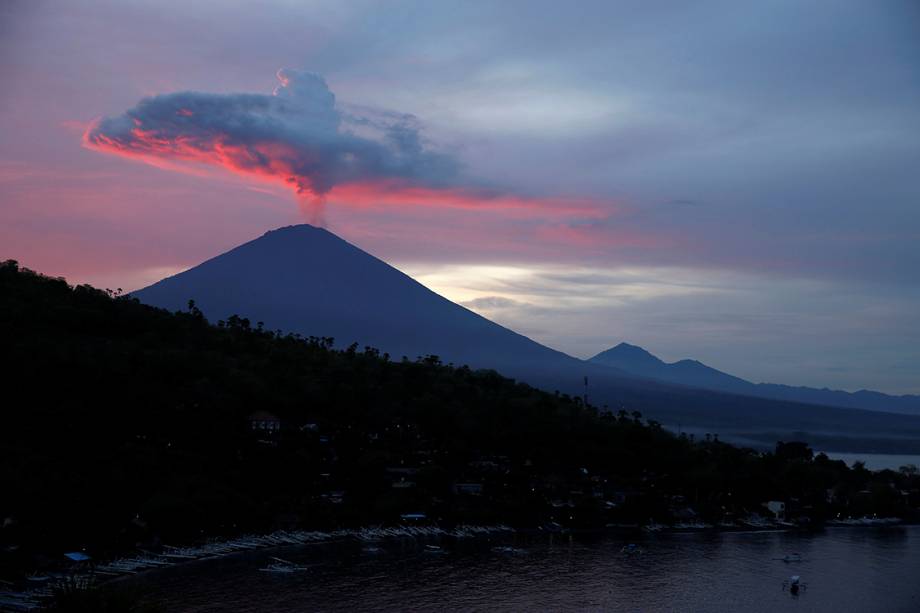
589, 343, 920, 415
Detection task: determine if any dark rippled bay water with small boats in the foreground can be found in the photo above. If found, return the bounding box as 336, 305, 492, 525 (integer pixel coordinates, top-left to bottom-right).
127, 526, 920, 613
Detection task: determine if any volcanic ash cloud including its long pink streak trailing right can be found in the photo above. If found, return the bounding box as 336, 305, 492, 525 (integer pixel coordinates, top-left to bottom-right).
83, 69, 611, 223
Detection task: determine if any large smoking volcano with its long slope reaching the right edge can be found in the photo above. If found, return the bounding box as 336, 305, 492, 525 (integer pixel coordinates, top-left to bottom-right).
131, 225, 920, 453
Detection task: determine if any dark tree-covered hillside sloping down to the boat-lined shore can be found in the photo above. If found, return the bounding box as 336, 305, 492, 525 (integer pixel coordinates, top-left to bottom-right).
0, 261, 920, 570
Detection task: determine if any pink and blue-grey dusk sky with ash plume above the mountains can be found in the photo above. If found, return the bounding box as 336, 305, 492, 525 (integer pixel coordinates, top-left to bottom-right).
0, 0, 920, 393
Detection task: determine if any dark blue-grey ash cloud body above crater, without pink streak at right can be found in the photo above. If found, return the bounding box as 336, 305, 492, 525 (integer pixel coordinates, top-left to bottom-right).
84, 69, 459, 218
